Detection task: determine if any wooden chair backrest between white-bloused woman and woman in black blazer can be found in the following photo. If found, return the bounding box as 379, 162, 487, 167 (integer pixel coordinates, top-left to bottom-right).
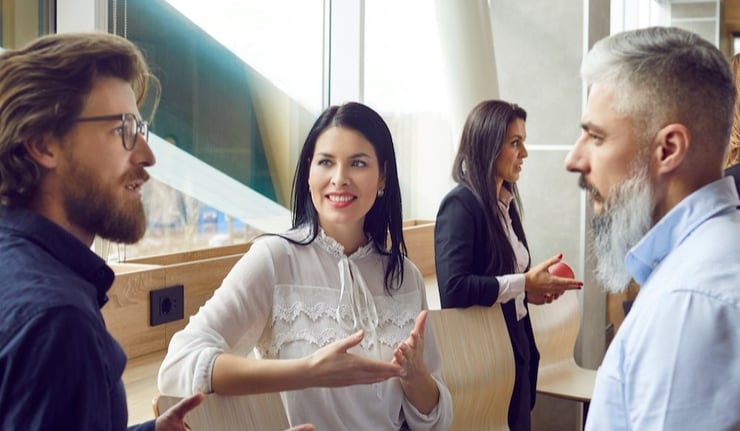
429, 305, 514, 431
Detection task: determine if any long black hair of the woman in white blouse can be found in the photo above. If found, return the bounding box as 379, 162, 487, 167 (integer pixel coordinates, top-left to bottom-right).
292, 102, 407, 294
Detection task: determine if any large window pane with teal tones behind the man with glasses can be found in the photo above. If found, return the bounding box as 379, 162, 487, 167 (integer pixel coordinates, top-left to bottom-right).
104, 0, 323, 260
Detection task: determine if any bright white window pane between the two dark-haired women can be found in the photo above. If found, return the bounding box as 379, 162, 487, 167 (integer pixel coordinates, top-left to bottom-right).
364, 0, 456, 218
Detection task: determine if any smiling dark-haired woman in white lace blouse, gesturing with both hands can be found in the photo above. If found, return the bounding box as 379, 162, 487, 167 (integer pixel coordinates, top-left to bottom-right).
159, 103, 452, 431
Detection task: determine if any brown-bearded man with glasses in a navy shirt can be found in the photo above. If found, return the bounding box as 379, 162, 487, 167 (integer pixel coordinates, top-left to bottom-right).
0, 33, 203, 431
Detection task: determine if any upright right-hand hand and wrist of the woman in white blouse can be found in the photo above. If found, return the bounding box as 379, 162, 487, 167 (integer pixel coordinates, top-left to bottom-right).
391, 310, 439, 414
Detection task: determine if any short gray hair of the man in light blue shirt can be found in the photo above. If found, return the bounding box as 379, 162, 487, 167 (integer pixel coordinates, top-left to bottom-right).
581, 27, 736, 154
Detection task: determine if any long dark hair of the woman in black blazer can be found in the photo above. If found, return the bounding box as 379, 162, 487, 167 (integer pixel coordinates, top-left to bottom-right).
452, 100, 529, 275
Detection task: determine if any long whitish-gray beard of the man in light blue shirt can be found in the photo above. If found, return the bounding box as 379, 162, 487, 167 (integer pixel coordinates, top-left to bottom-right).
591, 168, 655, 293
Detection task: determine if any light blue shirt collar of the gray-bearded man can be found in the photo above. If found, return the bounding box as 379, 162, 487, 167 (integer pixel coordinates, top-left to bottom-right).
624, 177, 738, 285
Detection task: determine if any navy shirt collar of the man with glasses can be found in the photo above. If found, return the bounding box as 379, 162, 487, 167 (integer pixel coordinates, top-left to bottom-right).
0, 205, 115, 307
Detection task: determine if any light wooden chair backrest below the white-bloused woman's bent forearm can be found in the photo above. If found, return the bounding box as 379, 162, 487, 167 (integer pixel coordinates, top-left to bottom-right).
154, 393, 289, 431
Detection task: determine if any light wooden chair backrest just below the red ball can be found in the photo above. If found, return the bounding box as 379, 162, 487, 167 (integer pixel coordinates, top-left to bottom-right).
529, 290, 581, 371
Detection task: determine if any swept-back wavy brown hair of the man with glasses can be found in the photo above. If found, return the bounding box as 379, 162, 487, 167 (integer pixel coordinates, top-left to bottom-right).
0, 32, 150, 206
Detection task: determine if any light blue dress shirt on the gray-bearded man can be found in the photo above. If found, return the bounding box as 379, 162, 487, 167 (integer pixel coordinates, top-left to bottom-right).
586, 178, 740, 431
